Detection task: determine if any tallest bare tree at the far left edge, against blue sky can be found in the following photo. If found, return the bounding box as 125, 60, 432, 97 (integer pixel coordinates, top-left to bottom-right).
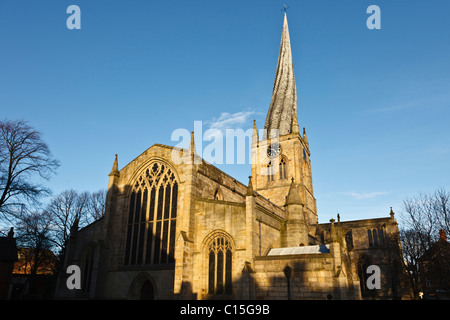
0, 120, 59, 218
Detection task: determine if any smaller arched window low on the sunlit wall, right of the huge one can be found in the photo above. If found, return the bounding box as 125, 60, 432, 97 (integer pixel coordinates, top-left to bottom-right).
208, 234, 233, 294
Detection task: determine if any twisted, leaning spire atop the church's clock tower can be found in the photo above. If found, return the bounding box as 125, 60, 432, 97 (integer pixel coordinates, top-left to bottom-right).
264, 13, 299, 139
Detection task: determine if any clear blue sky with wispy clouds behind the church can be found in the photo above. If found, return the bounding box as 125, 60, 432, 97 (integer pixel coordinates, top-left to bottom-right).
0, 0, 450, 222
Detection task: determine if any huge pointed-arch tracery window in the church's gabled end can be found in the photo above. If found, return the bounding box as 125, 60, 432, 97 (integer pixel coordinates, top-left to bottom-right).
124, 162, 178, 265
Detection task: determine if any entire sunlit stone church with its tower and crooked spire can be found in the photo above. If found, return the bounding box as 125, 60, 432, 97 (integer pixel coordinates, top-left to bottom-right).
56, 15, 409, 299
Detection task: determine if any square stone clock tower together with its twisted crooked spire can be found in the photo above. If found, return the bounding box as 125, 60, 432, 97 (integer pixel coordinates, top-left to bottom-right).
252, 13, 318, 224
